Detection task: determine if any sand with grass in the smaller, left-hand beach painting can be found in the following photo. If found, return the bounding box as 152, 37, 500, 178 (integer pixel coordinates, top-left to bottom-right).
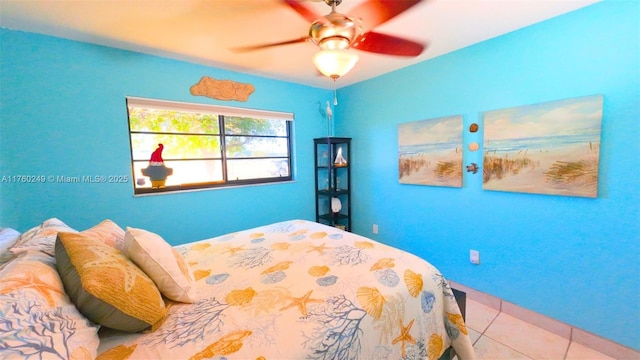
398, 149, 462, 187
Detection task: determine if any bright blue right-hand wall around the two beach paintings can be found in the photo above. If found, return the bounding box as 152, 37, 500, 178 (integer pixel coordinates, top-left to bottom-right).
336, 1, 640, 349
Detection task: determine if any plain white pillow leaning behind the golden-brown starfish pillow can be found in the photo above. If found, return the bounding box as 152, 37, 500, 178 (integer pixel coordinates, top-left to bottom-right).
124, 227, 196, 303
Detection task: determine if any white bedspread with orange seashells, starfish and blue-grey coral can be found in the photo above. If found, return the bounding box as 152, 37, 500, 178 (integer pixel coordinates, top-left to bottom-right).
98, 220, 474, 360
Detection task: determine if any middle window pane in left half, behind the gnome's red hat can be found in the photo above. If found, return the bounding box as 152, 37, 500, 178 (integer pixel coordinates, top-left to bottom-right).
131, 134, 221, 160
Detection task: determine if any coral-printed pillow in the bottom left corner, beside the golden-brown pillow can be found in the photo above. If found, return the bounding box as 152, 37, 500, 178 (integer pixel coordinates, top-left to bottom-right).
0, 251, 99, 360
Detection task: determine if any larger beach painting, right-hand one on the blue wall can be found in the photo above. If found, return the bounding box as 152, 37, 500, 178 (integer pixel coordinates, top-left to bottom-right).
482, 95, 603, 198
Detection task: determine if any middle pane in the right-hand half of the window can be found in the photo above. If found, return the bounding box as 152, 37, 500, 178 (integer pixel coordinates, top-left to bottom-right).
225, 136, 289, 158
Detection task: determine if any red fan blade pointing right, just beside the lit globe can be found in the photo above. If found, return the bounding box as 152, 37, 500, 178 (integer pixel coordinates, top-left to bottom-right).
351, 31, 425, 56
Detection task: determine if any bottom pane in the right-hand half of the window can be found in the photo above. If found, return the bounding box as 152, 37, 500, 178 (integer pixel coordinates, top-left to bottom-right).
227, 159, 289, 181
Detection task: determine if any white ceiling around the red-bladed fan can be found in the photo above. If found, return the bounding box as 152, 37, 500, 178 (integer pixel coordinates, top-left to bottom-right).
0, 0, 599, 89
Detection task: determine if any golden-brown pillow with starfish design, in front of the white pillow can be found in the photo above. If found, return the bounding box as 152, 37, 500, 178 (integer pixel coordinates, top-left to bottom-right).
55, 232, 166, 332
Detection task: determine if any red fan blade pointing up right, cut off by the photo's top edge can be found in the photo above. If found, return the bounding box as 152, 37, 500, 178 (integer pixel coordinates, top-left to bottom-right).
349, 0, 422, 30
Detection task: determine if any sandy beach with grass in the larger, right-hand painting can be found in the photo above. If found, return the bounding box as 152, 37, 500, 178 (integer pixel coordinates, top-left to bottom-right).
483, 143, 600, 197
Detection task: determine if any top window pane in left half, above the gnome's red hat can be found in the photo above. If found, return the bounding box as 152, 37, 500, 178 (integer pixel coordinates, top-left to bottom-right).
129, 107, 220, 134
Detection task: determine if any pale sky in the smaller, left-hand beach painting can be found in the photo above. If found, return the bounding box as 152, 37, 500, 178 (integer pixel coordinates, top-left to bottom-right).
398, 115, 462, 146
